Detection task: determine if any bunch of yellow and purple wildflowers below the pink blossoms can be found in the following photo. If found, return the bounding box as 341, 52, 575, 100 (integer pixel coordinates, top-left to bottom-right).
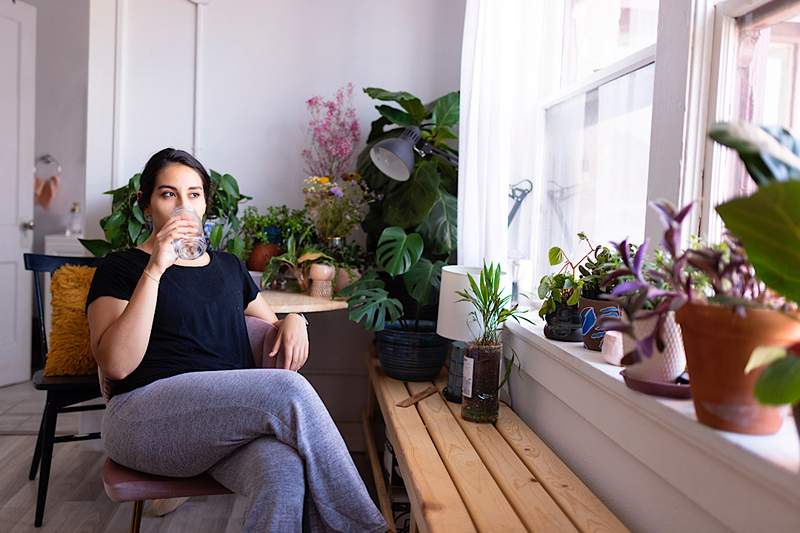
303, 173, 375, 242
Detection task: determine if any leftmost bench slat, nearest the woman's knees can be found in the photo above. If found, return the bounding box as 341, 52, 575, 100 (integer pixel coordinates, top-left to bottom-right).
369, 360, 477, 533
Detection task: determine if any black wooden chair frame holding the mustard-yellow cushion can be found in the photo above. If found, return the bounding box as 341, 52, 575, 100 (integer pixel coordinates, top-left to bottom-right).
24, 254, 105, 527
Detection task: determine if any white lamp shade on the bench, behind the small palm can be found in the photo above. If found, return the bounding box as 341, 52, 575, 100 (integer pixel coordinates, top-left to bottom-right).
436, 265, 481, 342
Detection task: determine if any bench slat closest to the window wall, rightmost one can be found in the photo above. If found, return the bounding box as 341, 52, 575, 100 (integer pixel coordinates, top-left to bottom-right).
496, 404, 628, 533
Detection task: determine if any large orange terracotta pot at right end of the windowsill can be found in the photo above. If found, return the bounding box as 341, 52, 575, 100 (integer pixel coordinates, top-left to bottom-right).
677, 303, 800, 435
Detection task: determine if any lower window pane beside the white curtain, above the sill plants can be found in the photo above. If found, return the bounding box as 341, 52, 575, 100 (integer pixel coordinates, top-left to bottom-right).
535, 64, 655, 276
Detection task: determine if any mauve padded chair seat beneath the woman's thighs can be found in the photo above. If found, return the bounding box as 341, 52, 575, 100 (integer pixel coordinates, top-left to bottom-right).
103, 458, 231, 502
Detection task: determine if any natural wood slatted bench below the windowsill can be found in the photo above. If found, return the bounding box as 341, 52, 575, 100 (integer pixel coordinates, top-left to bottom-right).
364, 358, 627, 533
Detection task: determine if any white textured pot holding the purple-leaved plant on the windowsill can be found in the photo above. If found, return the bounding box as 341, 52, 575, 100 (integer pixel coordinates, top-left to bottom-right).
623, 313, 686, 383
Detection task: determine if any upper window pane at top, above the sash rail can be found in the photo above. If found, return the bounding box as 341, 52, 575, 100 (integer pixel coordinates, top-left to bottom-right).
561, 0, 658, 85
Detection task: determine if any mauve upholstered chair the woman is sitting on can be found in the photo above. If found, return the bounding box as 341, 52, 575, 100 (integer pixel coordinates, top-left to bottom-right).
103, 317, 281, 533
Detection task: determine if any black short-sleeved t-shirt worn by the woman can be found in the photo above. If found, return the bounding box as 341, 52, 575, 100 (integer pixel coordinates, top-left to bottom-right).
86, 248, 259, 396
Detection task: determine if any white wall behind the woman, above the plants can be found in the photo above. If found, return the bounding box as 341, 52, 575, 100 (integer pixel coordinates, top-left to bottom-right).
87, 0, 464, 234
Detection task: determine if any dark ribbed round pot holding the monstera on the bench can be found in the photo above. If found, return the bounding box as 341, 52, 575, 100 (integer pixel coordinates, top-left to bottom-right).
375, 320, 450, 381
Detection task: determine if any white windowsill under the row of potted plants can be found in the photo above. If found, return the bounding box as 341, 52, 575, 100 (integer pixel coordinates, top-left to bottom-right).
506, 321, 800, 501
